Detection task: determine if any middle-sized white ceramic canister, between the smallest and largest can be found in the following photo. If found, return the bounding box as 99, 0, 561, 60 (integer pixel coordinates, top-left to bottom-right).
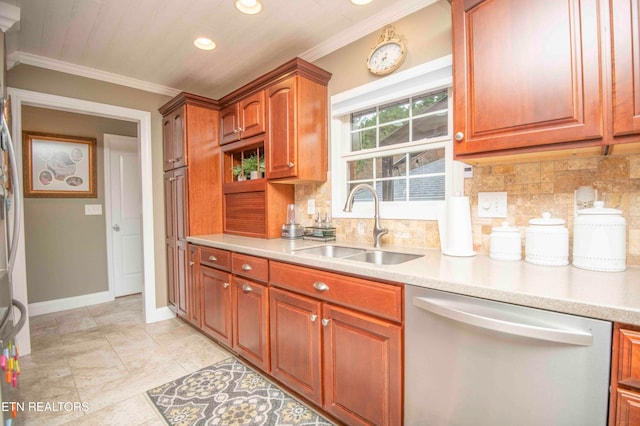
524, 212, 569, 266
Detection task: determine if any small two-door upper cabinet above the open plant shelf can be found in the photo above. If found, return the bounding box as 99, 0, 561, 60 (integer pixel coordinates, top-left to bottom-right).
220, 90, 265, 144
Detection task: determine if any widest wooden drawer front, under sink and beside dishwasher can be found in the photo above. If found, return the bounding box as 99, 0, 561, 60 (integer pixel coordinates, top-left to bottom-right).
269, 261, 402, 322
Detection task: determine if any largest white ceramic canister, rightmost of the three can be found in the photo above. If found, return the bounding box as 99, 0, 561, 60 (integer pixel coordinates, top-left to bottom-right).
573, 201, 627, 272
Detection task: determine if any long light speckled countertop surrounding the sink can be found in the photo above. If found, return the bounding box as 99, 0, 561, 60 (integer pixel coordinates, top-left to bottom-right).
187, 234, 640, 325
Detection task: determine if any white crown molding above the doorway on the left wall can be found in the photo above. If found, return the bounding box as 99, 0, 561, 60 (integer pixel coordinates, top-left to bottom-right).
7, 51, 180, 97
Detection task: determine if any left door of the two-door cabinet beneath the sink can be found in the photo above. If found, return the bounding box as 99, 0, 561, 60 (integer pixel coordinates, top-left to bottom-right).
269, 288, 322, 405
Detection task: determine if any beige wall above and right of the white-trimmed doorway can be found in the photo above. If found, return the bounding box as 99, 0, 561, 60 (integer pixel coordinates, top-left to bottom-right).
7, 65, 170, 307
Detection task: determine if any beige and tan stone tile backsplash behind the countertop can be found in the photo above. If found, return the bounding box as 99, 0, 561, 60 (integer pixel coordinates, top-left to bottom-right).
296, 154, 640, 266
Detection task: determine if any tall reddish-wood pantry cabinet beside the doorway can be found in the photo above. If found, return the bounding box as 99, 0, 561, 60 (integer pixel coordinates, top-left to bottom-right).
159, 93, 222, 321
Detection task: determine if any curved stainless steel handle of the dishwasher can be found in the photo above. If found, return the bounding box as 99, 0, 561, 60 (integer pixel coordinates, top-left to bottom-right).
413, 297, 593, 346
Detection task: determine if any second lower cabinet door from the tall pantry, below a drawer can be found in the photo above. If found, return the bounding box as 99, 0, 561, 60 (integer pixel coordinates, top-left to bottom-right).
200, 265, 232, 347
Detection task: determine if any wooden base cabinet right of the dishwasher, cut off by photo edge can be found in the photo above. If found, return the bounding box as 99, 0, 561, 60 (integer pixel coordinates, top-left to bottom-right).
609, 323, 640, 426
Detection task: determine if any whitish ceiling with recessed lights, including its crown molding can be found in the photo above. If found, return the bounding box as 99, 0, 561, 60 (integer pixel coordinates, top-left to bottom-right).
4, 0, 436, 99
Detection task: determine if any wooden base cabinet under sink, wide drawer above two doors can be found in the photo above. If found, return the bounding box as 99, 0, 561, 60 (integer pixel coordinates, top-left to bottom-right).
269, 261, 402, 425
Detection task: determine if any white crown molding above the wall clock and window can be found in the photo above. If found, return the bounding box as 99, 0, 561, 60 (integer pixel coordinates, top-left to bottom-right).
298, 0, 438, 62
